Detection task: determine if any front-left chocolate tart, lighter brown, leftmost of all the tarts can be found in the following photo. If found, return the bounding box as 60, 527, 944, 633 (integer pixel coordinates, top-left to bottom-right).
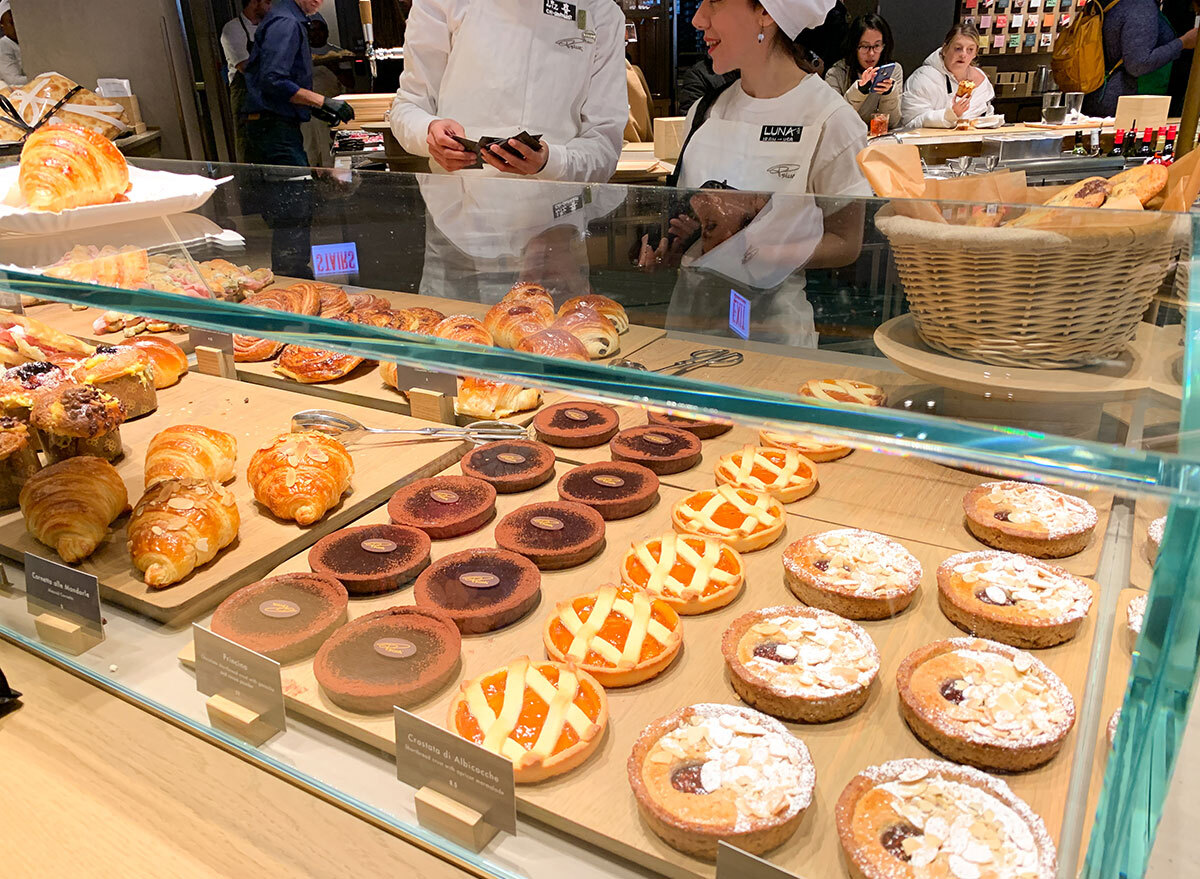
209, 574, 348, 663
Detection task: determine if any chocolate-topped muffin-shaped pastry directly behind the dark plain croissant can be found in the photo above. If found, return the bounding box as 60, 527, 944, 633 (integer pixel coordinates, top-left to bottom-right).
30, 384, 125, 462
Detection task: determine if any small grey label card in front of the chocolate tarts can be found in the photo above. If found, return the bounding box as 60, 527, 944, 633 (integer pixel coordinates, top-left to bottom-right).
192, 623, 288, 731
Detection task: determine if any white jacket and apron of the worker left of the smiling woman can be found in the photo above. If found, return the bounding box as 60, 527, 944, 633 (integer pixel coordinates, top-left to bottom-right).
389, 0, 629, 183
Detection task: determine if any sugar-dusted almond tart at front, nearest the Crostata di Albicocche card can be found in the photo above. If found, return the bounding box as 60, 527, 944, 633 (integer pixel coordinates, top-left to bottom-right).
626, 702, 816, 861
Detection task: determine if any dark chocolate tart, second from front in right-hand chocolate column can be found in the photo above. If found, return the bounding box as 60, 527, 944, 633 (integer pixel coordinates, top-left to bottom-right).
413, 549, 541, 635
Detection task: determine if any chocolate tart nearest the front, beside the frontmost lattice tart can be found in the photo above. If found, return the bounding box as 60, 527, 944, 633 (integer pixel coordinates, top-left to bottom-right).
312, 608, 462, 714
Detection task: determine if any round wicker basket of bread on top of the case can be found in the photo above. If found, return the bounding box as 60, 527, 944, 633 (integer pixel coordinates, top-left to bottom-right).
875, 207, 1186, 369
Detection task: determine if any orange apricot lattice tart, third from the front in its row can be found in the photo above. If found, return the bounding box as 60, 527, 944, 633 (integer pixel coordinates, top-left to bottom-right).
620, 533, 745, 615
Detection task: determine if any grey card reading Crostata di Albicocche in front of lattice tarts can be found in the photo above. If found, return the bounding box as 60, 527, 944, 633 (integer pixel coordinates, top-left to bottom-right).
396, 708, 517, 833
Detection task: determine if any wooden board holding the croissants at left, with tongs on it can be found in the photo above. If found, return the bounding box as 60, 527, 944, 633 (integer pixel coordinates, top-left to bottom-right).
0, 373, 469, 623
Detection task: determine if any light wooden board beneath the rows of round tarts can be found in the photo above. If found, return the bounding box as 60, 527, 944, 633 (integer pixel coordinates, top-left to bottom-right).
192, 446, 1094, 878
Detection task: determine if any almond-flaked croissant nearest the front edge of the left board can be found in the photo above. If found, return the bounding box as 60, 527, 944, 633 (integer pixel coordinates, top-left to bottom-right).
127, 479, 241, 588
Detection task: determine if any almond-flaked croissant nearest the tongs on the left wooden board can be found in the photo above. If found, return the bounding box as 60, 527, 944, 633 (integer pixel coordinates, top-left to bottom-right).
246, 433, 354, 525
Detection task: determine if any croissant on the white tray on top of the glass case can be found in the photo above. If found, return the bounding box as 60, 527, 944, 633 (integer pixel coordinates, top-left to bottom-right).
17, 125, 130, 213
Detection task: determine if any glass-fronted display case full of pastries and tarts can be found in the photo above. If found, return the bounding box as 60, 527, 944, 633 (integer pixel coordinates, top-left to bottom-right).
0, 162, 1200, 879
